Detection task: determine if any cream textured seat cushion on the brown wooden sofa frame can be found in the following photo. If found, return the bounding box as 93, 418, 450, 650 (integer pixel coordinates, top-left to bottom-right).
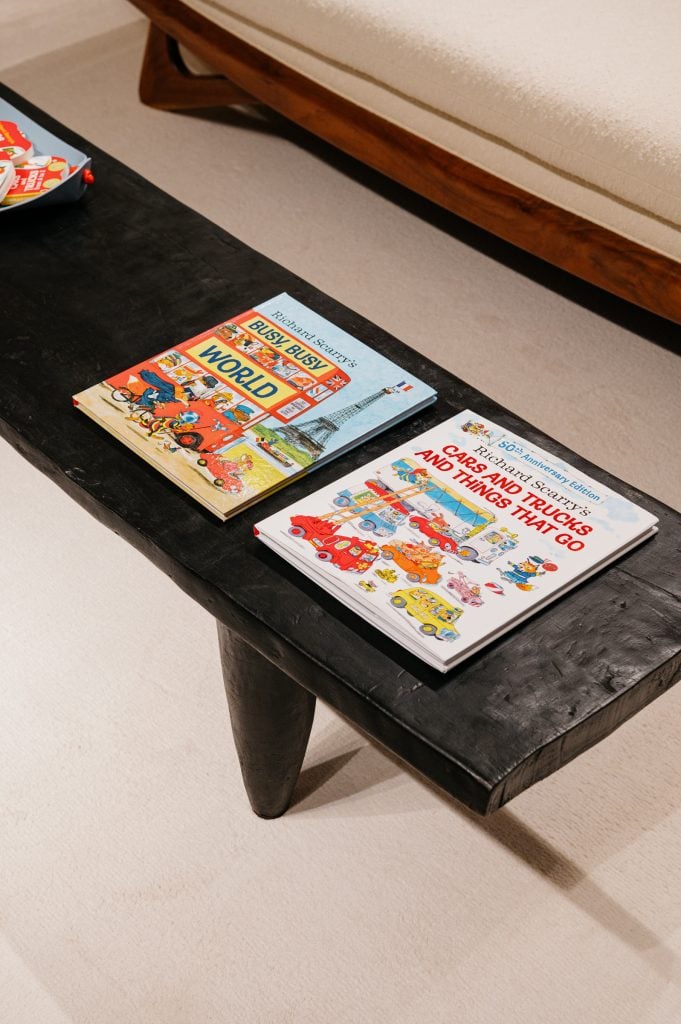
183, 0, 681, 259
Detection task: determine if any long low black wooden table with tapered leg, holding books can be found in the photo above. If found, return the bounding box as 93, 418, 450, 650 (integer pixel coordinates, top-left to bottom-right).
0, 90, 681, 817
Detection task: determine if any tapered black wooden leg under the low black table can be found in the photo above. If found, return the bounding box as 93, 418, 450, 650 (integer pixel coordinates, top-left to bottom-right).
217, 623, 315, 818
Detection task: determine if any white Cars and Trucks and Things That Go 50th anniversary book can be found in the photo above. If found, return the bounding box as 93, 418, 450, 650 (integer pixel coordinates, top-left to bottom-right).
255, 410, 657, 672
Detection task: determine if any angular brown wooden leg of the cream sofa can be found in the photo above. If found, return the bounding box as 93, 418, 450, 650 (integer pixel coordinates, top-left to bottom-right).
139, 22, 257, 111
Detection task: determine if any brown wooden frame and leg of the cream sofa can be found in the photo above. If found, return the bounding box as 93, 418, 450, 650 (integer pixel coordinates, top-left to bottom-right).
132, 0, 681, 323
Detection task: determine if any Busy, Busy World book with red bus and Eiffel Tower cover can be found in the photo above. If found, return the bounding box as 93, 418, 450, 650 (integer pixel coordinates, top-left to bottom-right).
74, 294, 435, 519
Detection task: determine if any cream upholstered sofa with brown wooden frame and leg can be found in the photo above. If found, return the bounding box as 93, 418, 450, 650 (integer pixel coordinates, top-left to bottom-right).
133, 0, 681, 322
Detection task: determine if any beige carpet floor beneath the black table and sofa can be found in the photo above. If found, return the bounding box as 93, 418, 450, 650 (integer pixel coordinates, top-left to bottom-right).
0, 9, 681, 1024
